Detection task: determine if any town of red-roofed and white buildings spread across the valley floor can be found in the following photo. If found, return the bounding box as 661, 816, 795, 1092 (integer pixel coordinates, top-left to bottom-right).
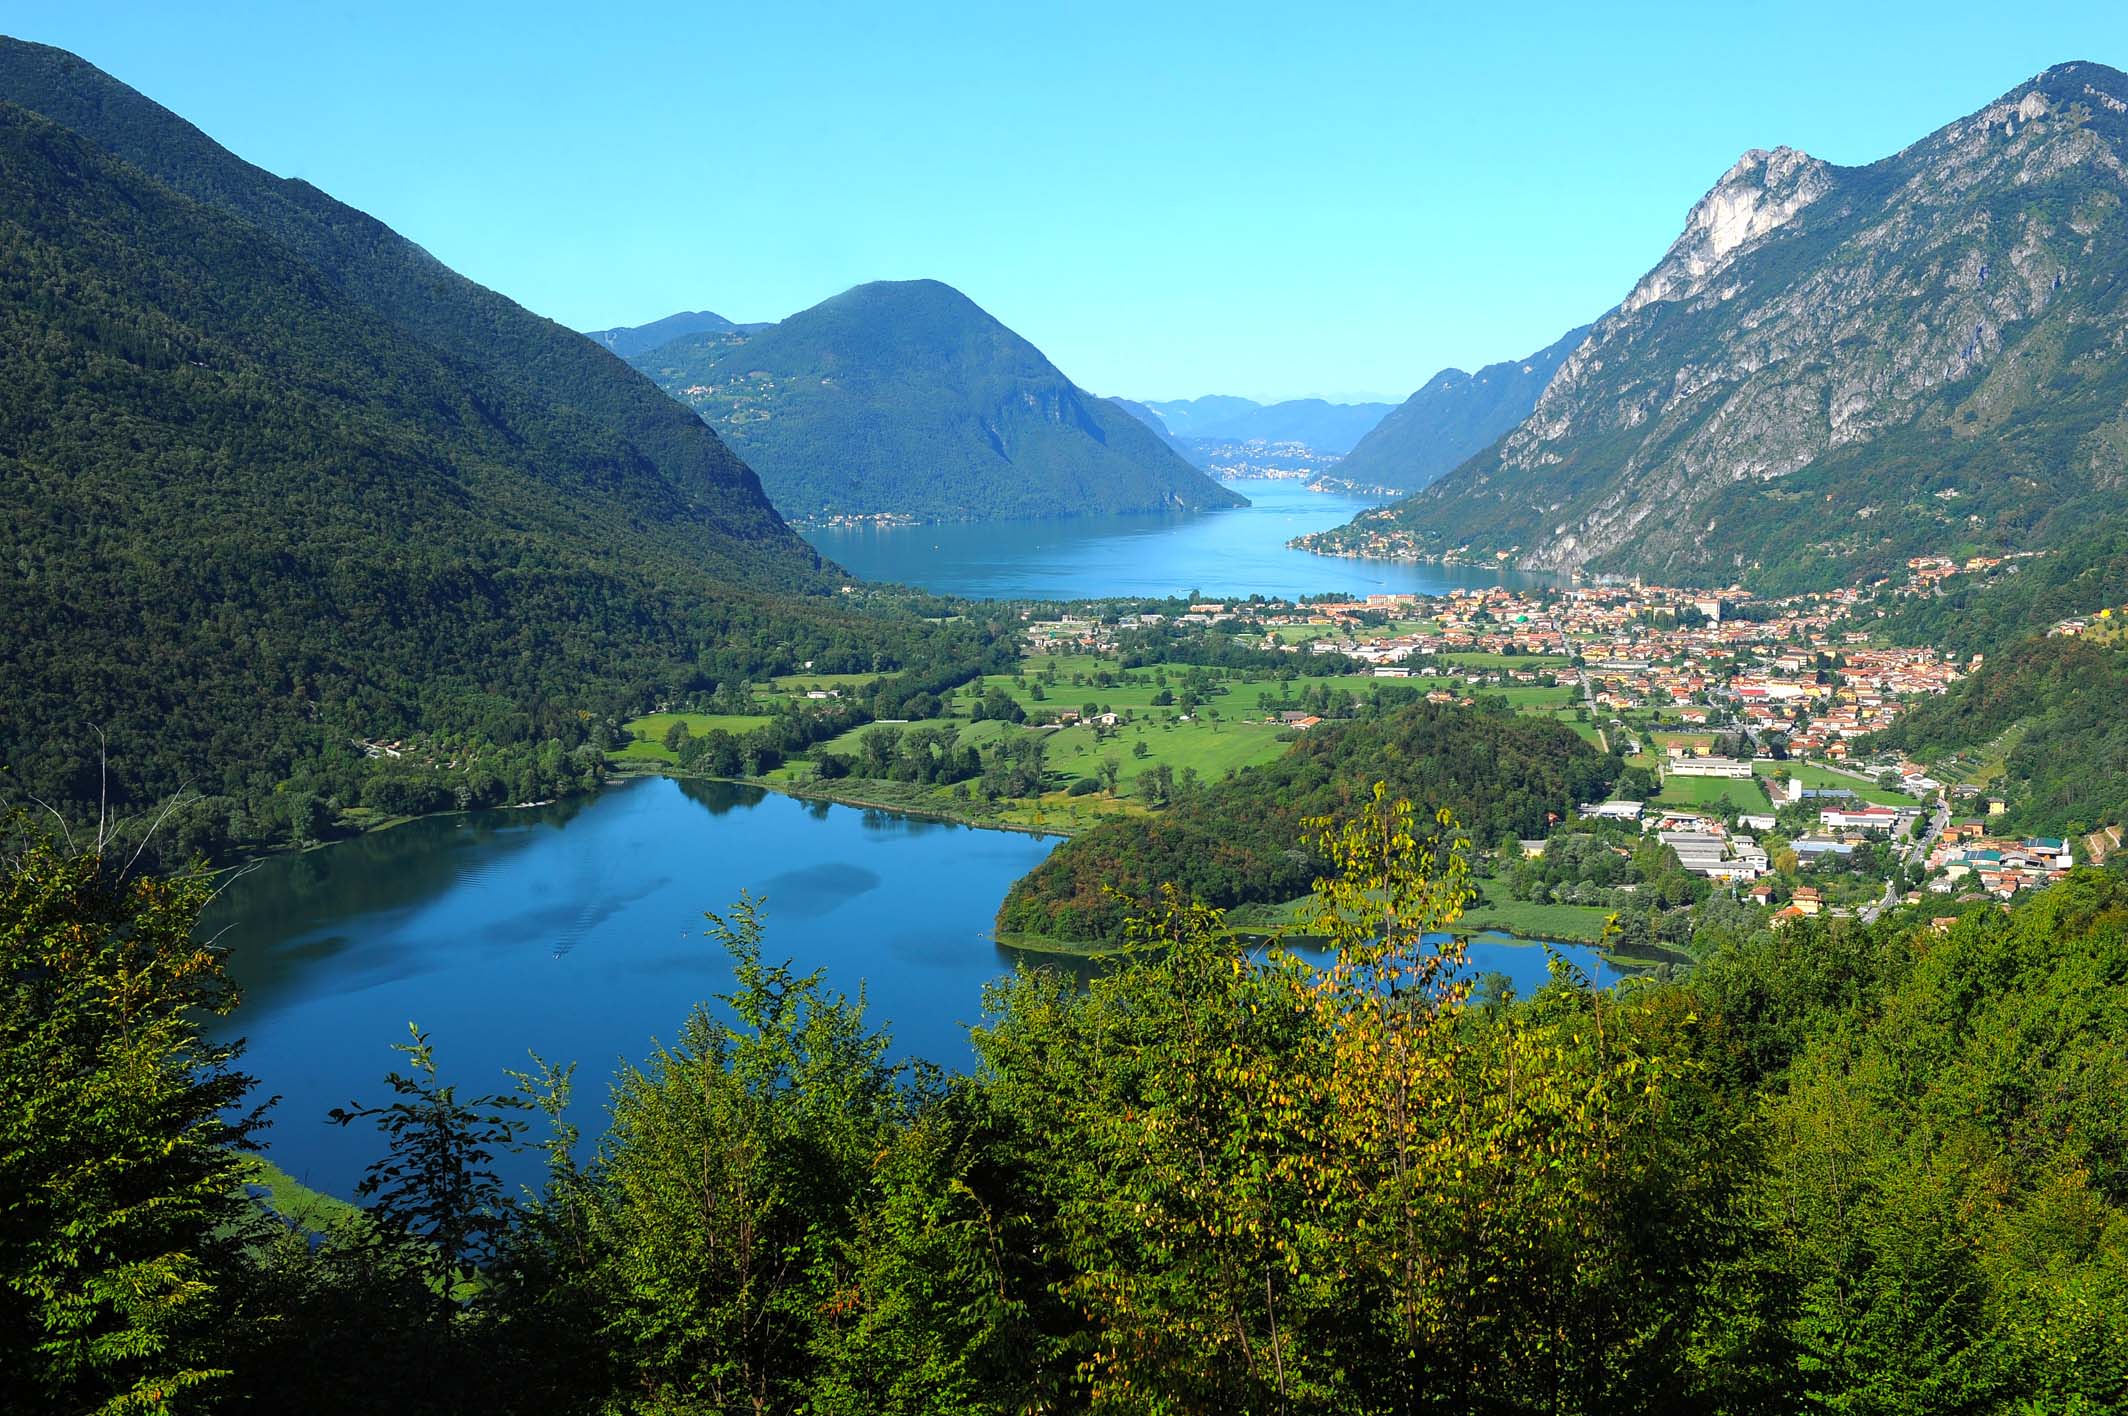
1026, 556, 2119, 924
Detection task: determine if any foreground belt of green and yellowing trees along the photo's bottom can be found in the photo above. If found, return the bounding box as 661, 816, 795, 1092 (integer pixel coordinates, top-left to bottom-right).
16, 796, 2128, 1416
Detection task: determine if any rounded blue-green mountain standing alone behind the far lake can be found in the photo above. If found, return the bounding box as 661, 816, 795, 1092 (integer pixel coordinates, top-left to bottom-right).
630, 281, 1247, 522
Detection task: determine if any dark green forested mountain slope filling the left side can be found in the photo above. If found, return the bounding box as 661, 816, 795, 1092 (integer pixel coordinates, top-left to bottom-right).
0, 40, 880, 837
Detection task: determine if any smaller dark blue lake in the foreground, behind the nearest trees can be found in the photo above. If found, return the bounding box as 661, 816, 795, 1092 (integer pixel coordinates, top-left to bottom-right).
204, 777, 1617, 1197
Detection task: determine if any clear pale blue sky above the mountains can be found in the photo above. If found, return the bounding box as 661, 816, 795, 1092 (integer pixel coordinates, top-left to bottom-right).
0, 0, 2128, 398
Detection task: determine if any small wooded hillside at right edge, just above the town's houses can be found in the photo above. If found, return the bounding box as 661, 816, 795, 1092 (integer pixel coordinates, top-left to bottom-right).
1873, 637, 2128, 835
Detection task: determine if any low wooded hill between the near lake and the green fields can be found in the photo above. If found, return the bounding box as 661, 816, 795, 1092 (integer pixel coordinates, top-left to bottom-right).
998, 698, 1622, 941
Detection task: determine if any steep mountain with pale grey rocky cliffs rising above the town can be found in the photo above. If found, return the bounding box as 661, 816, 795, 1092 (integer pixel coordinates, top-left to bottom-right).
1313, 64, 2128, 590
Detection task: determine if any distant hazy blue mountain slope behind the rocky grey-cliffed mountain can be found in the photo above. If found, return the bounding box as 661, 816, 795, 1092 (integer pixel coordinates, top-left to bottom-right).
1336, 326, 1592, 492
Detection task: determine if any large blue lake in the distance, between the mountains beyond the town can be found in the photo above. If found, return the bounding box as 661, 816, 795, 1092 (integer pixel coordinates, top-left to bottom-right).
807, 479, 1534, 600
